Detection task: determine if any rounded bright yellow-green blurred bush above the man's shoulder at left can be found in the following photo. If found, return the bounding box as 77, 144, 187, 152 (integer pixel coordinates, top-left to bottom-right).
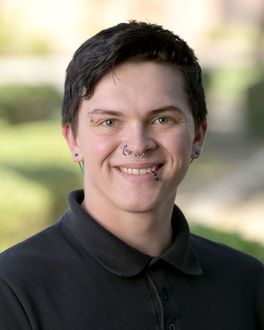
0, 167, 52, 250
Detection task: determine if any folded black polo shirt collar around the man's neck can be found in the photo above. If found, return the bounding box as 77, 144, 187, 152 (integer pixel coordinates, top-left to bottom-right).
62, 190, 202, 277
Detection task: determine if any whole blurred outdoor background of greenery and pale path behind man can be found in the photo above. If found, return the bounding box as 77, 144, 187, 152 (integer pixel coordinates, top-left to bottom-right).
0, 0, 264, 260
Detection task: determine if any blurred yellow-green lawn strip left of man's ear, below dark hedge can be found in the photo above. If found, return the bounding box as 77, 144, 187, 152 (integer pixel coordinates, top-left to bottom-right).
0, 121, 68, 164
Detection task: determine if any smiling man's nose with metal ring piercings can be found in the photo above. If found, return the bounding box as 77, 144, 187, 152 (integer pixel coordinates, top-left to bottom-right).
123, 124, 157, 155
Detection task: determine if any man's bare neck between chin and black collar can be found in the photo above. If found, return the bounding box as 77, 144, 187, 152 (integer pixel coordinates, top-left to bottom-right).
83, 198, 174, 256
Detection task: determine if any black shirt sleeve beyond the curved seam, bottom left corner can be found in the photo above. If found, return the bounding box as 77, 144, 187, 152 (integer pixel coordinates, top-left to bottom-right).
0, 278, 31, 330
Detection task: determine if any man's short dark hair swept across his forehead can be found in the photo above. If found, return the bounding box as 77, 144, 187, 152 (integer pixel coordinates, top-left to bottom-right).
62, 21, 207, 133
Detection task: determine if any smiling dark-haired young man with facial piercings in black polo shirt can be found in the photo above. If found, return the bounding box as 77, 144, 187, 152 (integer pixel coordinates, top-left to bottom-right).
0, 22, 264, 330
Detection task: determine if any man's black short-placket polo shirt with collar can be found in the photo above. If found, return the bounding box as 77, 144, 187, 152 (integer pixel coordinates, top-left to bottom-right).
0, 191, 264, 330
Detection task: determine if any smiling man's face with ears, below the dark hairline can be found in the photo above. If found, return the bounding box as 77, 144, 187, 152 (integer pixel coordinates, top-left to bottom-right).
65, 61, 206, 214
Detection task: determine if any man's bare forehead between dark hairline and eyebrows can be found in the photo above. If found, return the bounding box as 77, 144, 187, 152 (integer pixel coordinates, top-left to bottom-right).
80, 61, 189, 113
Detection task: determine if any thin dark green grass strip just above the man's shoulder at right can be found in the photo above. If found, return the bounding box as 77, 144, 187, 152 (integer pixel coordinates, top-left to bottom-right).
191, 225, 264, 261
